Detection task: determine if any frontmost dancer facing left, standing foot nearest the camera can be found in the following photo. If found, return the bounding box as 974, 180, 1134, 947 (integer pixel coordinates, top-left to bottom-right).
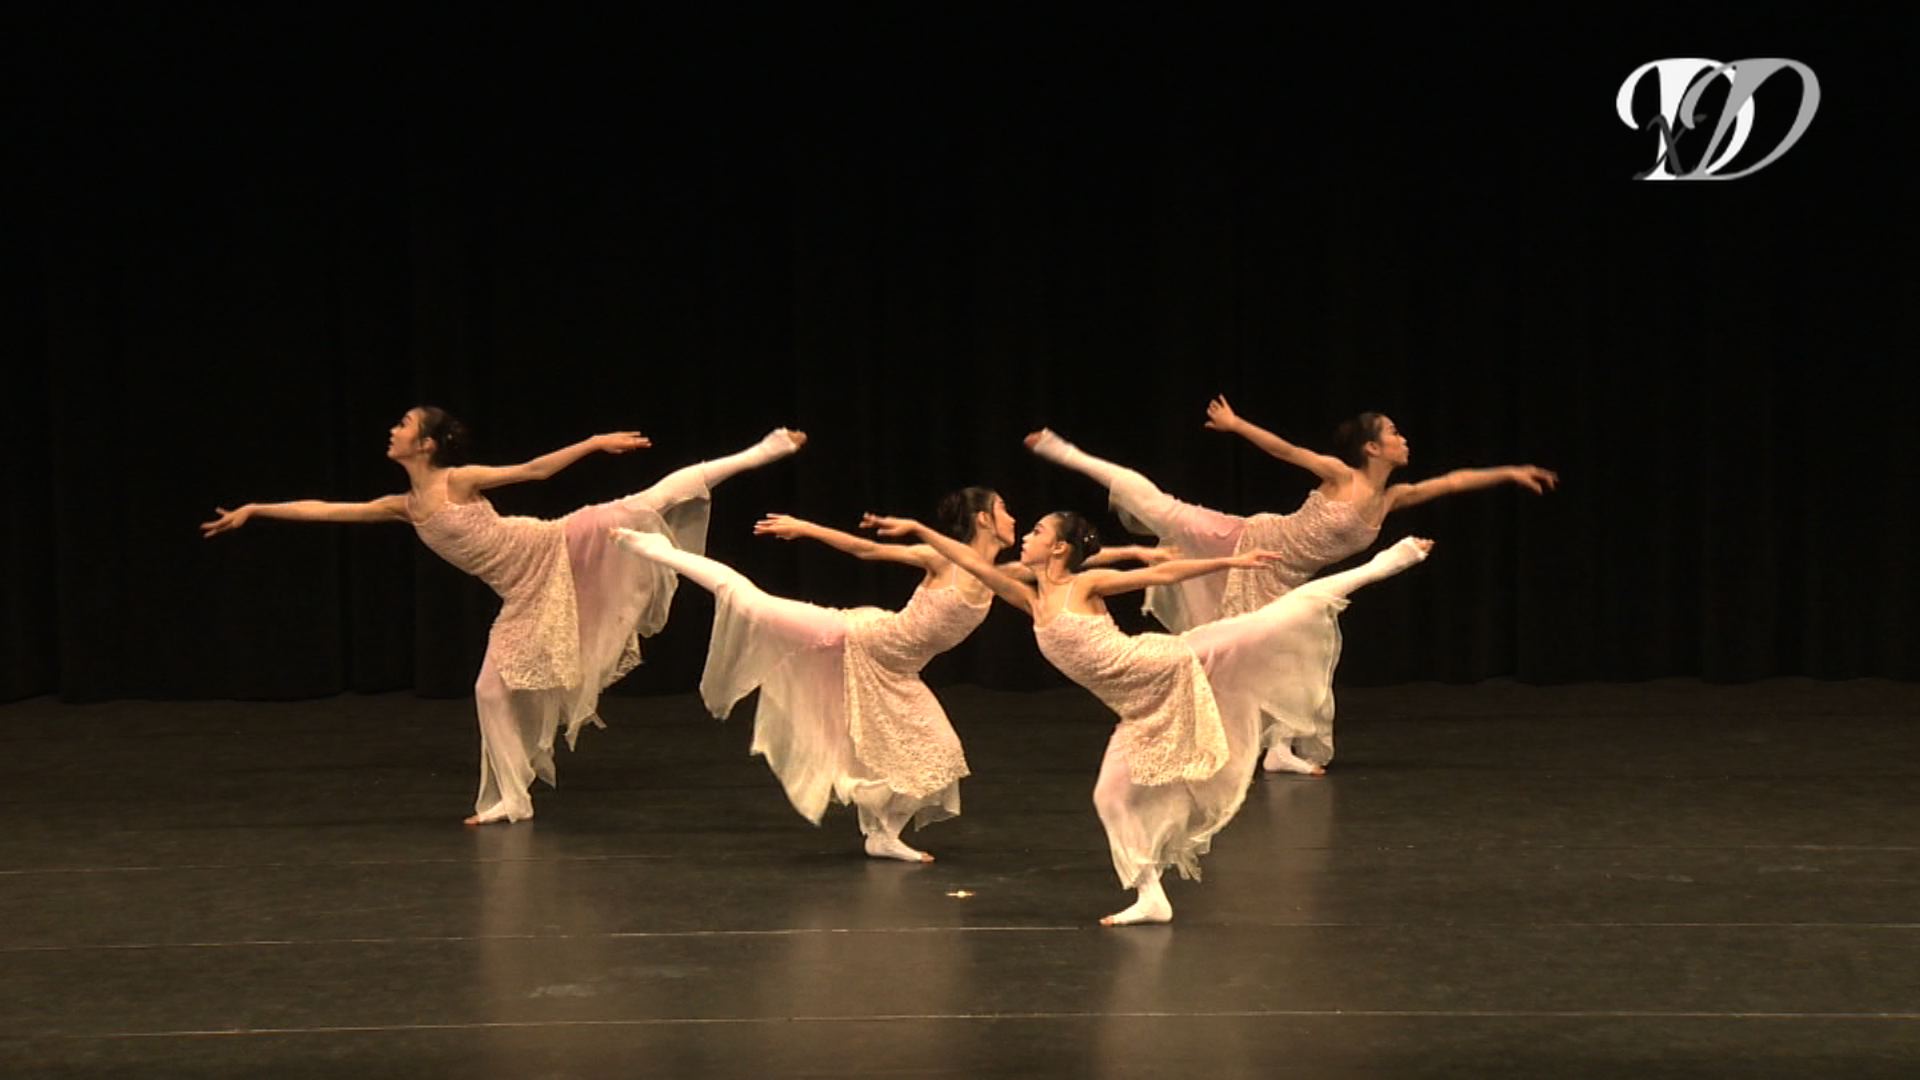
864, 499, 1432, 926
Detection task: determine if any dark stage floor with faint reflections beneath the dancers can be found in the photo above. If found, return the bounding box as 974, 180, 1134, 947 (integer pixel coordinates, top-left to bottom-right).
0, 682, 1920, 1080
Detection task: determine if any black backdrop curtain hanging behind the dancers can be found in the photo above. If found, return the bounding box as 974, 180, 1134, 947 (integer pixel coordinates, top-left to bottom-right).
0, 4, 1920, 700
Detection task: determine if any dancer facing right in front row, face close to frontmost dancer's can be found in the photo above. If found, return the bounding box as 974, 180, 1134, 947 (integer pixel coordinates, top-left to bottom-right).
614, 488, 1014, 863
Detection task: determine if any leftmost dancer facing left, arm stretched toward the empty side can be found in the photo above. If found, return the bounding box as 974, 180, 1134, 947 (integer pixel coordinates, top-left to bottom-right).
200, 405, 806, 824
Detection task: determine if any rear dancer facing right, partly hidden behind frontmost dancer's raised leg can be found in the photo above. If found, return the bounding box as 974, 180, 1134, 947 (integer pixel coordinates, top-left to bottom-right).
1027, 396, 1559, 776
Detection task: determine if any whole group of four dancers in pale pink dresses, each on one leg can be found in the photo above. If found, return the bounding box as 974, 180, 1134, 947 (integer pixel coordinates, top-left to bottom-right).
202, 398, 1557, 926
